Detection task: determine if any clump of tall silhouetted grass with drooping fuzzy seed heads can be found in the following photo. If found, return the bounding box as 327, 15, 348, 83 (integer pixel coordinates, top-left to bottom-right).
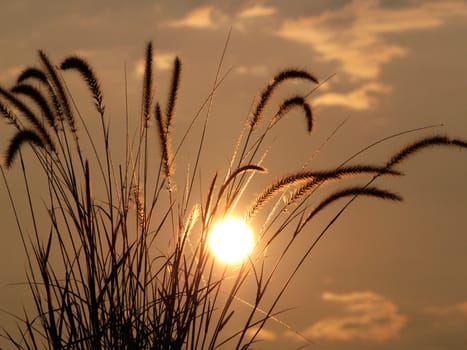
0, 43, 467, 350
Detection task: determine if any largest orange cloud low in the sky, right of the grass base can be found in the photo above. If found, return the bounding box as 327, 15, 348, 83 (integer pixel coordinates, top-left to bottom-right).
303, 291, 407, 342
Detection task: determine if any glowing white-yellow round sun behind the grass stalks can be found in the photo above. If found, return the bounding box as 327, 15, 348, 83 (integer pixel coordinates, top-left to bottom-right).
208, 217, 254, 264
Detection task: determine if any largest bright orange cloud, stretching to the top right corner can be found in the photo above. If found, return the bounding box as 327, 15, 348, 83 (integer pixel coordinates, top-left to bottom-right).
277, 0, 467, 79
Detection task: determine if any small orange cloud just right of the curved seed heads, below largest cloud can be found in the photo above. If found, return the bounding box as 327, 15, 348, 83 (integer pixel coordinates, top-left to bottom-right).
313, 82, 391, 110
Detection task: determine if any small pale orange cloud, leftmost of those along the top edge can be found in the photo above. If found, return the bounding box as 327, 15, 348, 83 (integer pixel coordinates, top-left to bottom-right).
166, 6, 225, 29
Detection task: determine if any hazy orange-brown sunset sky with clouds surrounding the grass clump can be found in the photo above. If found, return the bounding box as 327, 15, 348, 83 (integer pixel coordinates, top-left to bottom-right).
0, 0, 467, 350
